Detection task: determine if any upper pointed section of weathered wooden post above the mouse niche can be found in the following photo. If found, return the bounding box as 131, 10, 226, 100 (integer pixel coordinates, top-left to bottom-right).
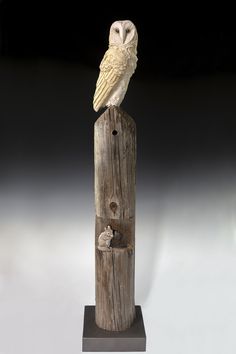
94, 106, 136, 219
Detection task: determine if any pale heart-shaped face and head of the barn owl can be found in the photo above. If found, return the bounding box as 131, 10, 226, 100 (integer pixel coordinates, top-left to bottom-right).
109, 20, 138, 48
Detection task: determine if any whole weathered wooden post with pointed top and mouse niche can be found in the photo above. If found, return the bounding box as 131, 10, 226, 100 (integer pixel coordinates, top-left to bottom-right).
94, 106, 136, 331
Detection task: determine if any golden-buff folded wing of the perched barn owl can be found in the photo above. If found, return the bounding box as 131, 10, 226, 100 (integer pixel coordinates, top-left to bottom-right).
93, 48, 128, 112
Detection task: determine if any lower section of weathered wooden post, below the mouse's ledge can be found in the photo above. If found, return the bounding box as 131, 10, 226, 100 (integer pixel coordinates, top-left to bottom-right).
96, 246, 135, 331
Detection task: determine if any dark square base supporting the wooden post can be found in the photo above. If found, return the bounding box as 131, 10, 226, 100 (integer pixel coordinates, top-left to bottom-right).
82, 306, 146, 352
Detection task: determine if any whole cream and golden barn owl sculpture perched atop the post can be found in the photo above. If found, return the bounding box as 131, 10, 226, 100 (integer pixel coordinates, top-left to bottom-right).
93, 20, 138, 112
